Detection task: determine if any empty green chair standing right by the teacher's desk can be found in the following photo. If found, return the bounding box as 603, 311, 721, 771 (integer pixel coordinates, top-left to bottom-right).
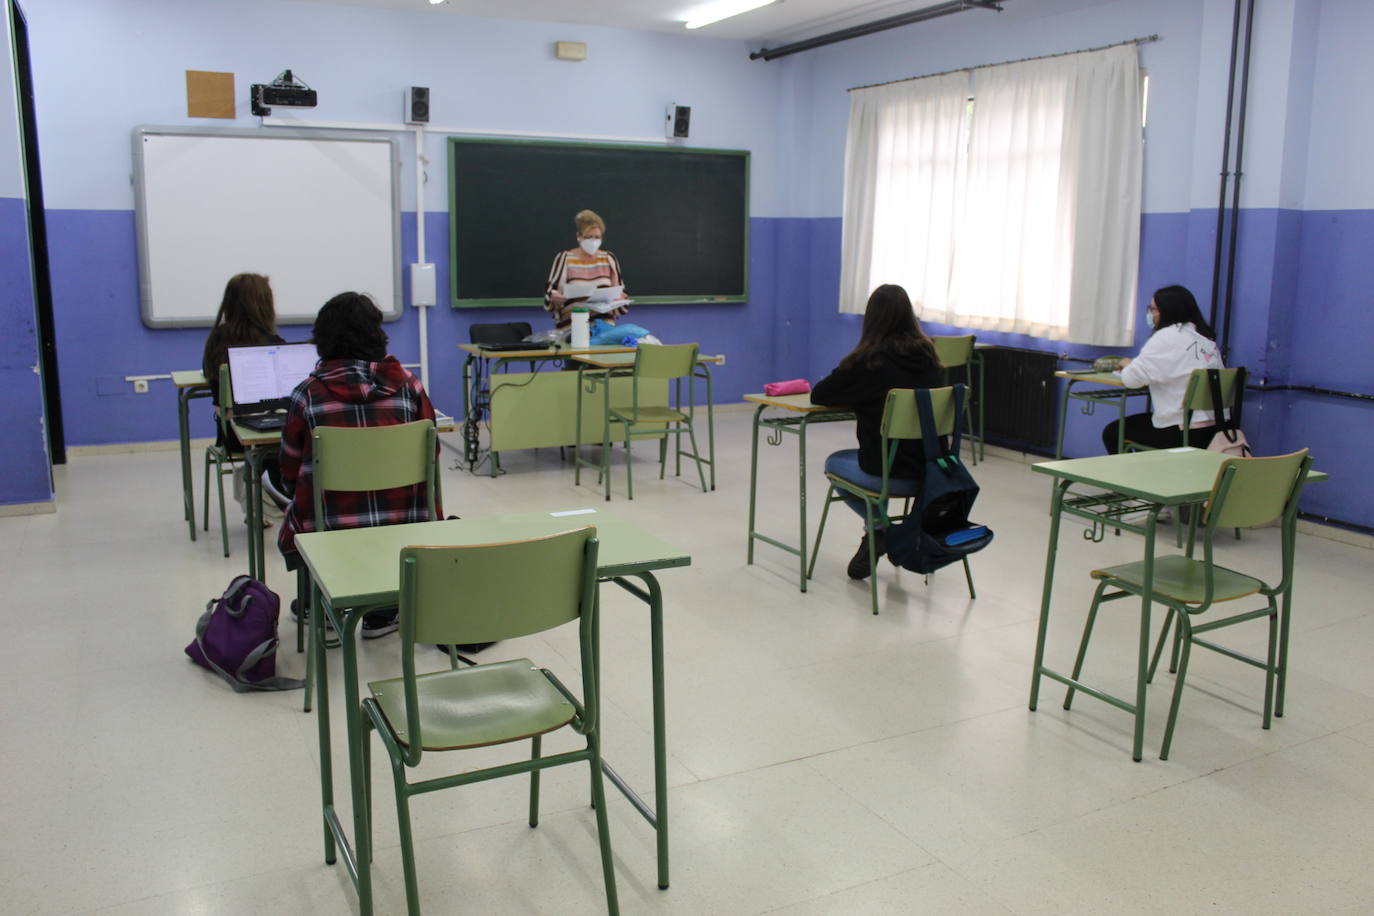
573, 343, 706, 500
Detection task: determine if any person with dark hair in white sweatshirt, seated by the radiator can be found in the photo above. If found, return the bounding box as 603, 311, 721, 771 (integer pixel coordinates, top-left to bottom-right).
1102, 286, 1223, 455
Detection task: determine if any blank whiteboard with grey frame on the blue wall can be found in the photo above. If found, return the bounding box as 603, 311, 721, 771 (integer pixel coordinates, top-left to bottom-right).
133, 126, 401, 327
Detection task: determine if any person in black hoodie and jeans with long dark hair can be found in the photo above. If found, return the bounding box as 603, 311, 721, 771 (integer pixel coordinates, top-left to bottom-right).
811, 283, 941, 580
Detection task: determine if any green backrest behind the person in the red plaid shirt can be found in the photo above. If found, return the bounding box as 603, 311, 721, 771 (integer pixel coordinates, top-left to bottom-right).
312, 420, 438, 531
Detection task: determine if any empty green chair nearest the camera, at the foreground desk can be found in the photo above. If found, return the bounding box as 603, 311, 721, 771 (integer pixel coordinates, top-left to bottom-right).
365, 527, 618, 915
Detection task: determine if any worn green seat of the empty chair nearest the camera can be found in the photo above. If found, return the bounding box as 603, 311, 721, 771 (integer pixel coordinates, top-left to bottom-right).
368, 658, 577, 751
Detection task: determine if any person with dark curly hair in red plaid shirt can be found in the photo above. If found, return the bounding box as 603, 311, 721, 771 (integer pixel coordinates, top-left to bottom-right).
270, 293, 444, 639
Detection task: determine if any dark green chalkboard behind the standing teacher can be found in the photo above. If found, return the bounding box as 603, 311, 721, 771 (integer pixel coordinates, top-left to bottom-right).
448, 137, 749, 308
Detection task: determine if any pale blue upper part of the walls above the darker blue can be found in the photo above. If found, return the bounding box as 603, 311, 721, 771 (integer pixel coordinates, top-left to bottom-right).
13, 0, 1374, 217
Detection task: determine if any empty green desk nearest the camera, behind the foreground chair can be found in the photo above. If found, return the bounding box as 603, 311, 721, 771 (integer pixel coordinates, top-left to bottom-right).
295, 511, 691, 915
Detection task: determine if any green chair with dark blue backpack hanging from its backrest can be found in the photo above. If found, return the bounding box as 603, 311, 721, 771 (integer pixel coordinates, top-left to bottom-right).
807, 387, 977, 614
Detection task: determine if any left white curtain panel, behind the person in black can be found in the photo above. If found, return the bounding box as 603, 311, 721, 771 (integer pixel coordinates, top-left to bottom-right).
840, 70, 969, 314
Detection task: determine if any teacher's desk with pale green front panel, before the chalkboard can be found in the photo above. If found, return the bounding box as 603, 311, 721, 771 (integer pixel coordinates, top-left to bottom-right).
458, 343, 634, 477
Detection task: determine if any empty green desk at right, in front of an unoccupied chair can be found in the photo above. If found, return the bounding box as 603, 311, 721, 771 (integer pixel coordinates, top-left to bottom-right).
1031, 448, 1327, 761
